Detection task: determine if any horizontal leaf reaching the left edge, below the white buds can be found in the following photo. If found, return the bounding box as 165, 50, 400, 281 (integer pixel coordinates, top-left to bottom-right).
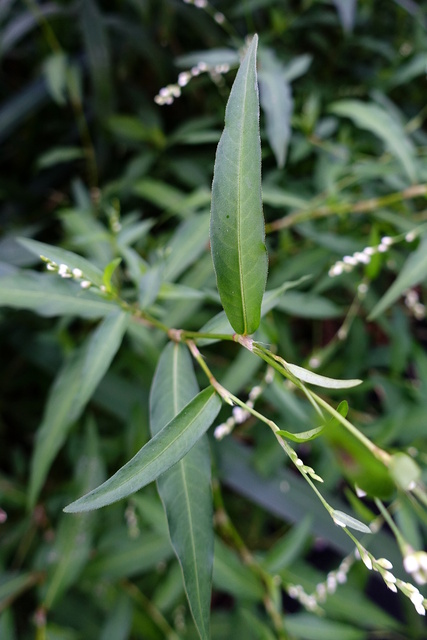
0, 271, 118, 318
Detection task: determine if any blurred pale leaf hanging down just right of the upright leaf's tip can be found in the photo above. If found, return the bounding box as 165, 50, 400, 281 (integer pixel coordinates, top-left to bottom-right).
258, 49, 293, 168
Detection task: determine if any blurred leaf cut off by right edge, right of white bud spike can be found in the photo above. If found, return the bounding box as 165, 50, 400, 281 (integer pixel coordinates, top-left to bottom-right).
368, 237, 427, 320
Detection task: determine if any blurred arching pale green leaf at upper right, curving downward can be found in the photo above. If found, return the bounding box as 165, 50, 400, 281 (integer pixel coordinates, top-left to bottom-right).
331, 100, 417, 182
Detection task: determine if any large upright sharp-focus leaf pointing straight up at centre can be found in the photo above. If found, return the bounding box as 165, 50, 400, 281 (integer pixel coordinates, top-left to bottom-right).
210, 36, 268, 335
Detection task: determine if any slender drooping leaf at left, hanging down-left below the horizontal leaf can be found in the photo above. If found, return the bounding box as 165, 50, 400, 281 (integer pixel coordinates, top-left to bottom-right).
29, 312, 128, 506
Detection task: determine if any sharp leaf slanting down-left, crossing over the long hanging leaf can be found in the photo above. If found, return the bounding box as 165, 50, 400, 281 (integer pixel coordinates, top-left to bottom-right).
64, 387, 221, 513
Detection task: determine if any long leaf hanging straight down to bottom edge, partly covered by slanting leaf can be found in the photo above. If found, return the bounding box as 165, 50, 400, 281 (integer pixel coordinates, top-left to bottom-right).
150, 343, 214, 640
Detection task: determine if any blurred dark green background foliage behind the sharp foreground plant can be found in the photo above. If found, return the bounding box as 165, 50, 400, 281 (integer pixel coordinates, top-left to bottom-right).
0, 0, 427, 640
